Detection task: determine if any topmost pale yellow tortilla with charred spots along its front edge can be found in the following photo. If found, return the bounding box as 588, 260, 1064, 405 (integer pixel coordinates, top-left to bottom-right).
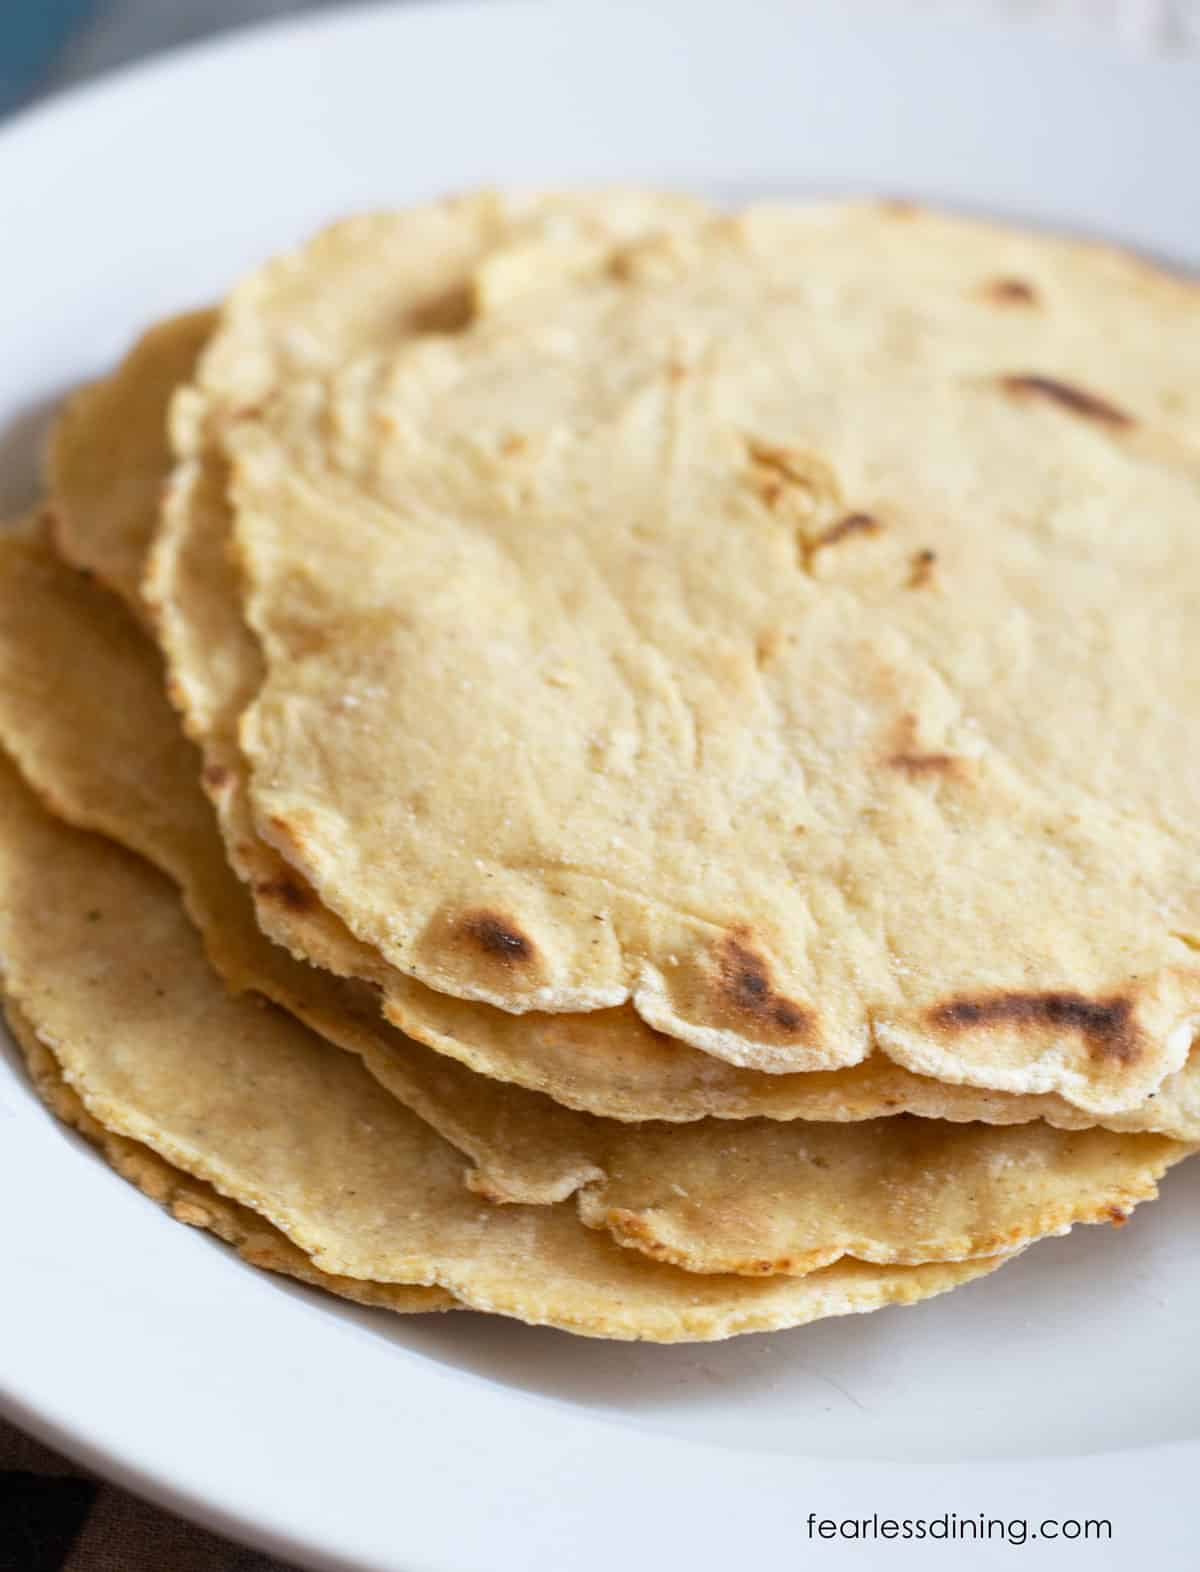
213, 208, 1200, 1115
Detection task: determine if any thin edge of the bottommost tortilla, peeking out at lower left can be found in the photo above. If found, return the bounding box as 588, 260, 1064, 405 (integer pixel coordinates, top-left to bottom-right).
5, 1001, 458, 1314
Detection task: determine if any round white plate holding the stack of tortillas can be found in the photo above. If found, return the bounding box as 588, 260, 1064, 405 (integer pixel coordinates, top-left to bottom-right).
0, 0, 1200, 1572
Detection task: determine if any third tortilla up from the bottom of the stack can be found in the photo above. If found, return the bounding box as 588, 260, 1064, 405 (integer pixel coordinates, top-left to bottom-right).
0, 539, 1200, 1275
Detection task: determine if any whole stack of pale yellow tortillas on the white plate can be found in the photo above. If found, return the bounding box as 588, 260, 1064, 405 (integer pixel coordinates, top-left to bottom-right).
0, 193, 1200, 1341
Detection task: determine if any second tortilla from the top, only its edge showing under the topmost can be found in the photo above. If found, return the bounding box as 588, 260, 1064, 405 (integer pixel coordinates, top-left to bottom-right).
46, 303, 1200, 1144
